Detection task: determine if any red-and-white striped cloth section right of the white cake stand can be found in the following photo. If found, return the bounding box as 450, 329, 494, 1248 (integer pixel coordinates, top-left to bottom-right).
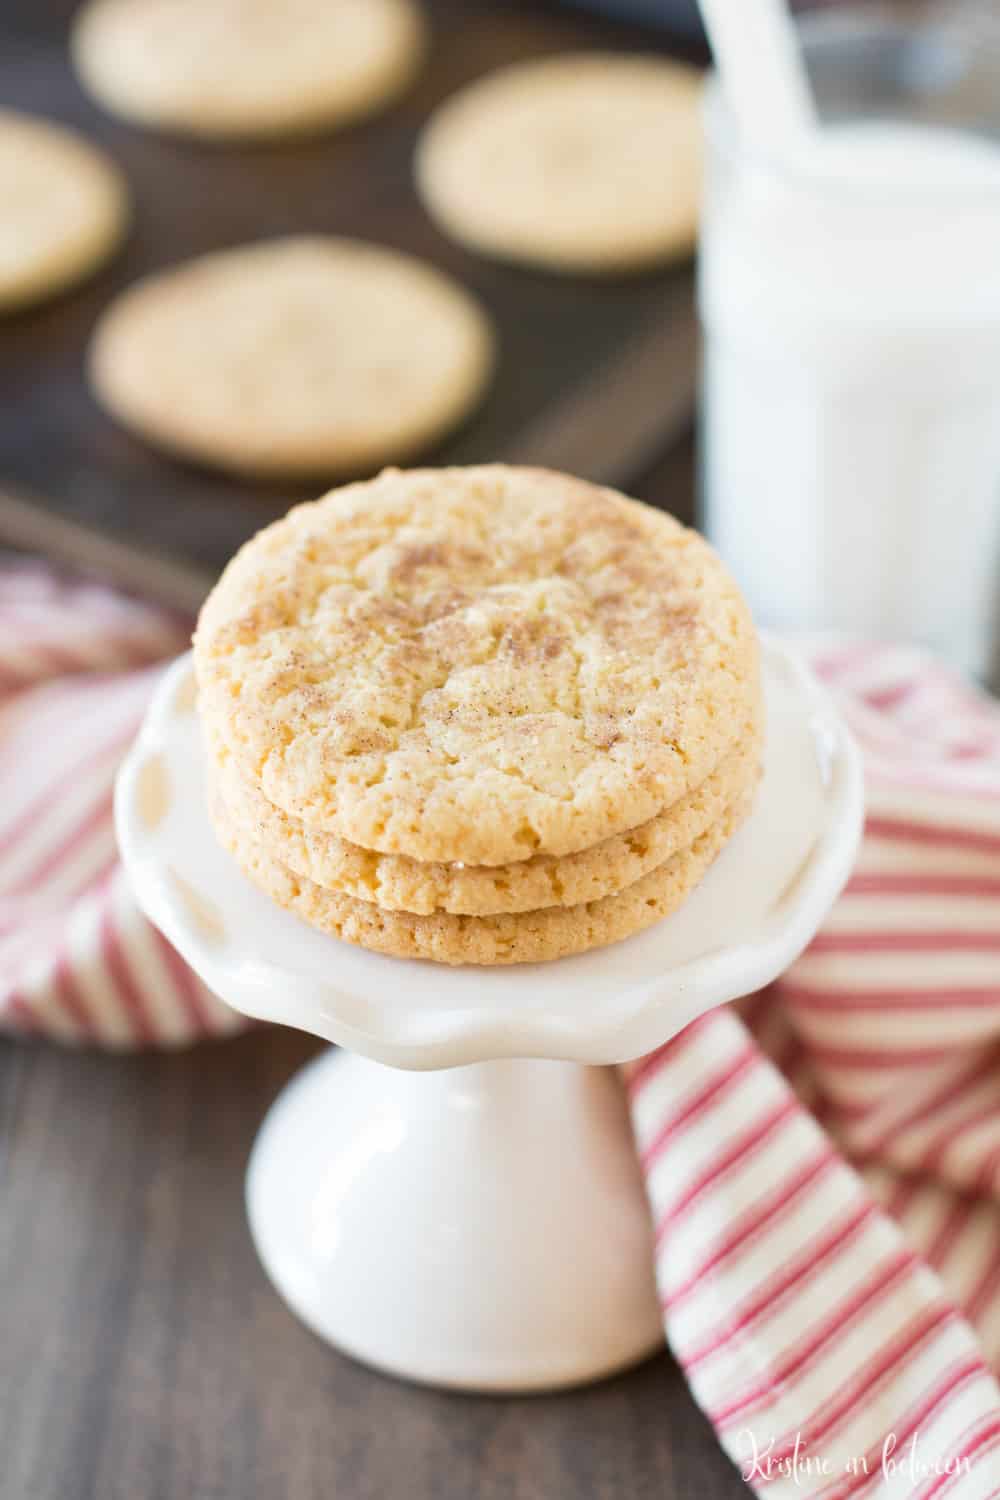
627, 647, 1000, 1500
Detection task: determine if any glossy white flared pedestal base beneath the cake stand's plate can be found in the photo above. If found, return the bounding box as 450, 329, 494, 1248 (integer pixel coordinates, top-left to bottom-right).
246, 1052, 663, 1391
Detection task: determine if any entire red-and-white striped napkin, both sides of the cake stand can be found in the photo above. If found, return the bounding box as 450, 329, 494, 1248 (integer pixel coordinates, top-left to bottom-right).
0, 566, 1000, 1500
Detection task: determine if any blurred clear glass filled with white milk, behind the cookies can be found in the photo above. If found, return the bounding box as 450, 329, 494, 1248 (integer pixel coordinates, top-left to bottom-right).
699, 3, 1000, 677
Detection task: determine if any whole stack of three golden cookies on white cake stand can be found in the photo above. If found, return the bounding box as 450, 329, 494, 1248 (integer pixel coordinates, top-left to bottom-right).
195, 465, 762, 965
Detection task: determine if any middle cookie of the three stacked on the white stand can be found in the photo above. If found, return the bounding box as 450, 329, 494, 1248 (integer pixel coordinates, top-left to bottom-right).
208, 723, 760, 917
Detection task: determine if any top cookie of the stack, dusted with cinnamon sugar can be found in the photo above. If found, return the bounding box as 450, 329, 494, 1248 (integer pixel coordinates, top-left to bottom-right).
195, 465, 760, 866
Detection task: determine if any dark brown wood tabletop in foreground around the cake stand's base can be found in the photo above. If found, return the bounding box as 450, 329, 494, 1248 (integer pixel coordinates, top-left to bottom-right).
0, 1029, 747, 1500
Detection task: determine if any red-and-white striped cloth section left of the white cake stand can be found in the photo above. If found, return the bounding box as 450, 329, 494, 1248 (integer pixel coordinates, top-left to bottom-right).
0, 566, 243, 1047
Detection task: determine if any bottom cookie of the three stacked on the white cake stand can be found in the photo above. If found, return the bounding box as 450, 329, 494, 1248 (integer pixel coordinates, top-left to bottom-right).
210, 797, 751, 966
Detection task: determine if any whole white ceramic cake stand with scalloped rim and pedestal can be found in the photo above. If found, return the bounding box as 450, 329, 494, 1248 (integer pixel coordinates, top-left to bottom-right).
115, 644, 862, 1391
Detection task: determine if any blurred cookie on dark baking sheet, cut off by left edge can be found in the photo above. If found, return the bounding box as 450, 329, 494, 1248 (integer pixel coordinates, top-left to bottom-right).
0, 110, 129, 312
